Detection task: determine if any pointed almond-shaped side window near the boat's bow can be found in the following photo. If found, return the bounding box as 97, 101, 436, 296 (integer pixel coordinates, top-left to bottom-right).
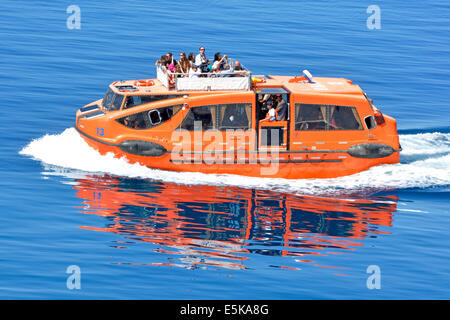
116, 105, 182, 130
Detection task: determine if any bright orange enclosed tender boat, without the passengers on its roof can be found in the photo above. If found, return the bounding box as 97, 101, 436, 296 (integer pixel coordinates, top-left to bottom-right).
75, 66, 401, 179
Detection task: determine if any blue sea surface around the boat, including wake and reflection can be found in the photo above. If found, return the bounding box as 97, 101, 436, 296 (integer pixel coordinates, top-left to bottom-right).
0, 0, 450, 299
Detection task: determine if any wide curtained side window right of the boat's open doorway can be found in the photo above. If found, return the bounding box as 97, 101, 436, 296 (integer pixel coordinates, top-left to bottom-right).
295, 103, 362, 131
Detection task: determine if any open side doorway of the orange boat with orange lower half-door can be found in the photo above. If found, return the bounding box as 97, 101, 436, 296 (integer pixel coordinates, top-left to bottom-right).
256, 88, 289, 151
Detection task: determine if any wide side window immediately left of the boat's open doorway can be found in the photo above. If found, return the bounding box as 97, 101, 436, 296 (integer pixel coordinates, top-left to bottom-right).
181, 103, 252, 131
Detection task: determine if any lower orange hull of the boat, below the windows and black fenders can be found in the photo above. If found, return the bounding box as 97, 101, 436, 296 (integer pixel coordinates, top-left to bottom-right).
77, 129, 400, 179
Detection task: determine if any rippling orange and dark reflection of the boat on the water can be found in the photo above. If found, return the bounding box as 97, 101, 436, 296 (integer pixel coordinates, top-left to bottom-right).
74, 176, 397, 269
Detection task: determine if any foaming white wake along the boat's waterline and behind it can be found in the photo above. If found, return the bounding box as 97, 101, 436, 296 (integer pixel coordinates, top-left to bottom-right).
20, 128, 450, 194
